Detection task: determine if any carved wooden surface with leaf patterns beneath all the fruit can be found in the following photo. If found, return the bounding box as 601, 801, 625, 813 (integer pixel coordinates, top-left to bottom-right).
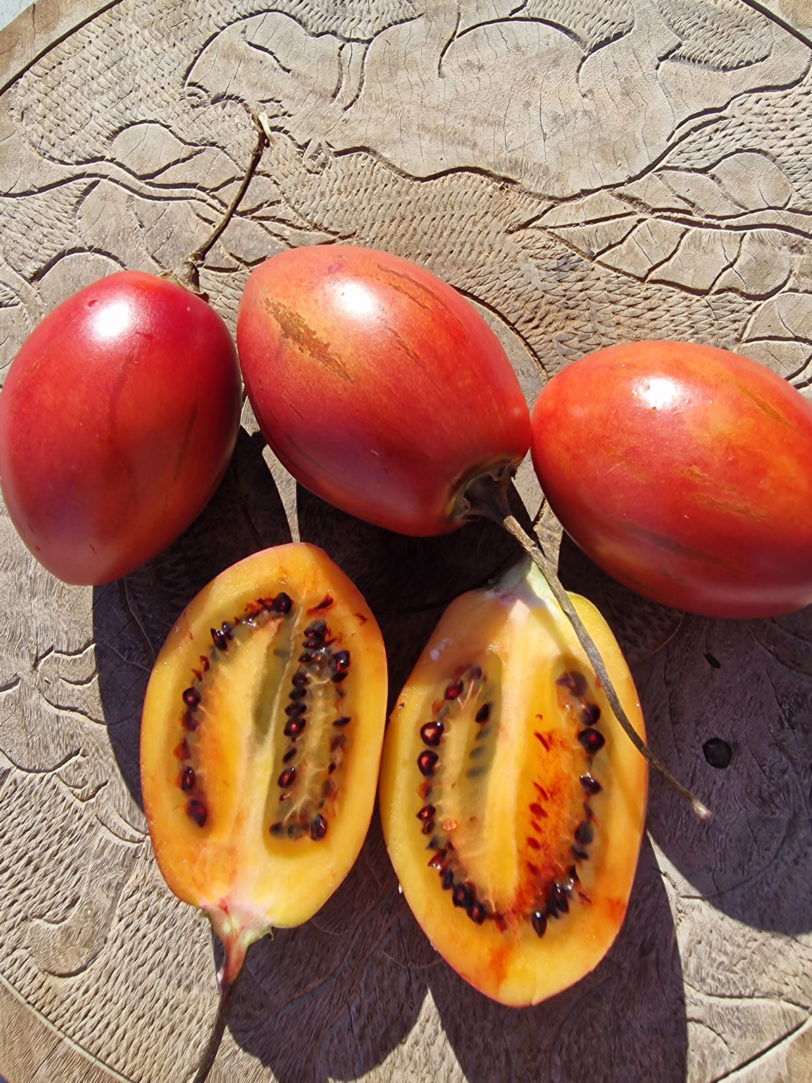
0, 0, 812, 1083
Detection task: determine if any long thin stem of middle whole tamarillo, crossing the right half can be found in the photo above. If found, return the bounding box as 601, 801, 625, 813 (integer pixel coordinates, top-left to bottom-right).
466, 473, 711, 820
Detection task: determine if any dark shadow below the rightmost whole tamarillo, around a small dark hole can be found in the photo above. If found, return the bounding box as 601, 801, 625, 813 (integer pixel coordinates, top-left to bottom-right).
560, 539, 812, 940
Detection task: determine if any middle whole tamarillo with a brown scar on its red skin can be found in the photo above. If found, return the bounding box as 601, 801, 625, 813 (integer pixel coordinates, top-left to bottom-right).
237, 245, 529, 536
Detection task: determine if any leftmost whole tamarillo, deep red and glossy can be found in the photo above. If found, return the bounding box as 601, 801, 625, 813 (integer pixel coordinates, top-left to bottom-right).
0, 271, 240, 584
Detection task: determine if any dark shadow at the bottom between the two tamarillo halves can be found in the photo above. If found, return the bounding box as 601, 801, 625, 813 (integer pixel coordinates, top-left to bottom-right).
214, 813, 428, 1083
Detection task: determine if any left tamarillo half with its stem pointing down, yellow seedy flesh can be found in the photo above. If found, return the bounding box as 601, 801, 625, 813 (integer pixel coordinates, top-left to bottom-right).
141, 543, 387, 1080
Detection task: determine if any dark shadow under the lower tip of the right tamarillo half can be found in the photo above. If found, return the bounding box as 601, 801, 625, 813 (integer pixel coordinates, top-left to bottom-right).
428, 841, 687, 1083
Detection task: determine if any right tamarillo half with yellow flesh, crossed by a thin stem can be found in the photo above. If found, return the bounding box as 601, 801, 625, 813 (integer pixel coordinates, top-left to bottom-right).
379, 561, 647, 1006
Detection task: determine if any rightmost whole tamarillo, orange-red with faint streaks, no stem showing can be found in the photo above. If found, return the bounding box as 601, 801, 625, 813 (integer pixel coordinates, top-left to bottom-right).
532, 342, 812, 617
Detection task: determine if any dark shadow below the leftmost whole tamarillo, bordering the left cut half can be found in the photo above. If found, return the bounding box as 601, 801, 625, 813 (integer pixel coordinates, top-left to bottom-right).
93, 429, 290, 809
